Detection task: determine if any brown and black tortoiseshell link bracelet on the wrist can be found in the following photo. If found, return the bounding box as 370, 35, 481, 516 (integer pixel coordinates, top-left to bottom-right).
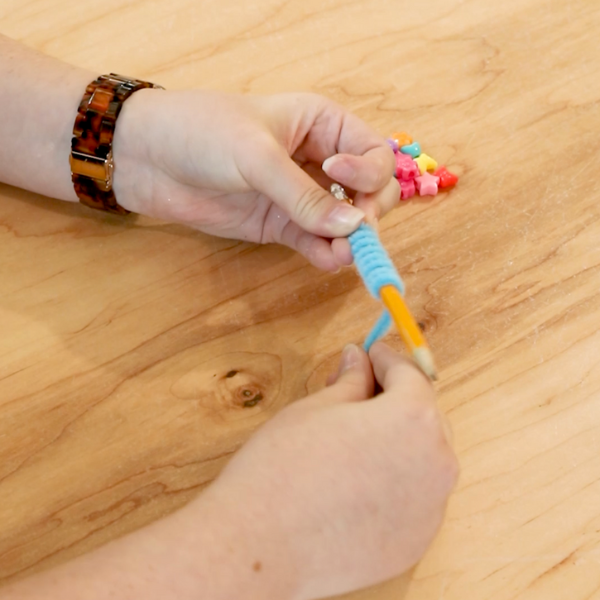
69, 73, 164, 215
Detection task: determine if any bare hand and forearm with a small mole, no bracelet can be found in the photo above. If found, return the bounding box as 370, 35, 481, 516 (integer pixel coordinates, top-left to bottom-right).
0, 344, 457, 600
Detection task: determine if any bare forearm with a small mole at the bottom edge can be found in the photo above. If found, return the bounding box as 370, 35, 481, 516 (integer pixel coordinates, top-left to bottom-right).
0, 490, 291, 600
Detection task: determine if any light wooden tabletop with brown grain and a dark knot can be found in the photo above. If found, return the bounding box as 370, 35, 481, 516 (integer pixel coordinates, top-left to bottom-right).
0, 0, 600, 600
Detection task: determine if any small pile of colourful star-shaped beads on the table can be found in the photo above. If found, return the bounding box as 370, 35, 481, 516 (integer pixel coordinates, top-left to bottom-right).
388, 132, 458, 200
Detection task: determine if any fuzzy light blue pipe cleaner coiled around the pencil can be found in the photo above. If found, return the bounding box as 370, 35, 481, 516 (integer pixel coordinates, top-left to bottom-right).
348, 223, 404, 352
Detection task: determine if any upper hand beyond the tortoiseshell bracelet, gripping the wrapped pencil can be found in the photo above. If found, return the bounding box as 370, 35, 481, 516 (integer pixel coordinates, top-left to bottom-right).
114, 90, 399, 271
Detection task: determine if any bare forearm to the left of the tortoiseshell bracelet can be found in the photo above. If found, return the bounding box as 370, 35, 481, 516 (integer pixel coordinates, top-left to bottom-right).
0, 35, 97, 202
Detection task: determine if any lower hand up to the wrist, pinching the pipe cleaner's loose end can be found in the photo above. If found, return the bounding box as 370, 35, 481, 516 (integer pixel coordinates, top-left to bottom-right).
199, 343, 458, 600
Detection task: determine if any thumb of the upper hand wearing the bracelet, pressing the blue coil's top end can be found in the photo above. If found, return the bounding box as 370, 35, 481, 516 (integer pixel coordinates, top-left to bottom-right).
249, 146, 365, 238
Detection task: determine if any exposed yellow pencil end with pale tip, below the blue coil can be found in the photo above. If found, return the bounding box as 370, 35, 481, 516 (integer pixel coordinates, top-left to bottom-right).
380, 285, 437, 381
